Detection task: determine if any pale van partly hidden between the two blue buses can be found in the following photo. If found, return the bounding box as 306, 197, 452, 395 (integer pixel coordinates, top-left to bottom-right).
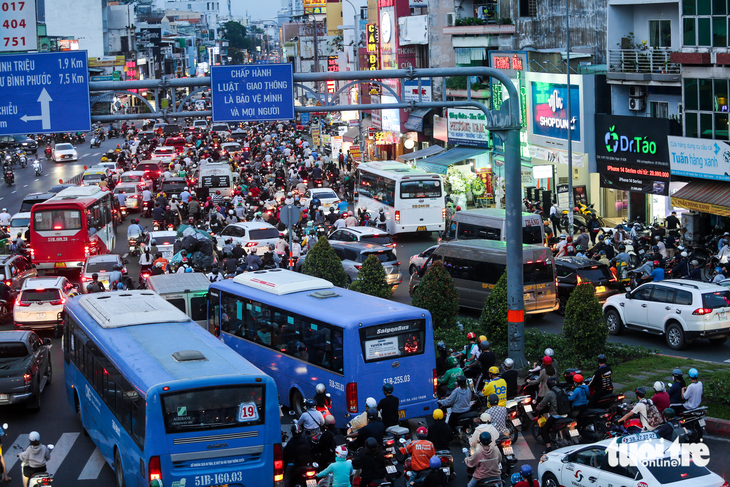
147, 272, 210, 329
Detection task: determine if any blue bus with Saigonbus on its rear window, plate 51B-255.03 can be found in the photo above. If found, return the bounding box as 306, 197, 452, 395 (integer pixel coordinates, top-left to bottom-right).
208, 269, 436, 427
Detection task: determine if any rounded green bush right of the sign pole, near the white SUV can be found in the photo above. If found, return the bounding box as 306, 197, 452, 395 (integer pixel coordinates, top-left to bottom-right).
563, 284, 608, 358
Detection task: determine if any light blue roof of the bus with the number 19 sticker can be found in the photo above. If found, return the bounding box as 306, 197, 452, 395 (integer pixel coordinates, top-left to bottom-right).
66, 291, 265, 395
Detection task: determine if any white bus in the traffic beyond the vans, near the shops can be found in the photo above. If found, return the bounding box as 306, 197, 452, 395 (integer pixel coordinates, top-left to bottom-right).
355, 161, 446, 235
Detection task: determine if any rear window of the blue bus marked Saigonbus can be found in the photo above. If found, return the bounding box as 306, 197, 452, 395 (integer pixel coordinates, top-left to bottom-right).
360, 320, 426, 363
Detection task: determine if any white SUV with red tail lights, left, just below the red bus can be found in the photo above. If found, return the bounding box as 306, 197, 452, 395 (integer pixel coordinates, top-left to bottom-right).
13, 276, 78, 338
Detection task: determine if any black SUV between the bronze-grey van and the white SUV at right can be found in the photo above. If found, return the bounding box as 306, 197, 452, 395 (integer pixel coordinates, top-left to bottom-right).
555, 257, 618, 315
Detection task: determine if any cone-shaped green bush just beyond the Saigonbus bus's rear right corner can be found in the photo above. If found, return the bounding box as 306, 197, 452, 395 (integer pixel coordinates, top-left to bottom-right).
411, 261, 459, 328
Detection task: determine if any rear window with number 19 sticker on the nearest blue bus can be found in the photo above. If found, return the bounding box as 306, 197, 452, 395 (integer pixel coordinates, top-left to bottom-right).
162, 385, 266, 434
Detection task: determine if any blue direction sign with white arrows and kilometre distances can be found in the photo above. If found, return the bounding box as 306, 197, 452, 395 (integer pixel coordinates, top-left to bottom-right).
0, 51, 91, 134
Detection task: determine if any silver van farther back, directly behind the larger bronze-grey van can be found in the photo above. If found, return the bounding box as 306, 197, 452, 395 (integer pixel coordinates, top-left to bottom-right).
444, 208, 545, 245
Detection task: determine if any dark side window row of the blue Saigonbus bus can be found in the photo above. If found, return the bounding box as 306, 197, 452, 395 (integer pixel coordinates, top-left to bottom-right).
219, 293, 343, 374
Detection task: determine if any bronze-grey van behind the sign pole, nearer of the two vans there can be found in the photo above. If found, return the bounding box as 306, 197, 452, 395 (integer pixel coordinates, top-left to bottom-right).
408, 240, 558, 315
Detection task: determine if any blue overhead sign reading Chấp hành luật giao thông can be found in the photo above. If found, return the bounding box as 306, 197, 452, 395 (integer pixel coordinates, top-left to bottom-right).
210, 64, 294, 122
